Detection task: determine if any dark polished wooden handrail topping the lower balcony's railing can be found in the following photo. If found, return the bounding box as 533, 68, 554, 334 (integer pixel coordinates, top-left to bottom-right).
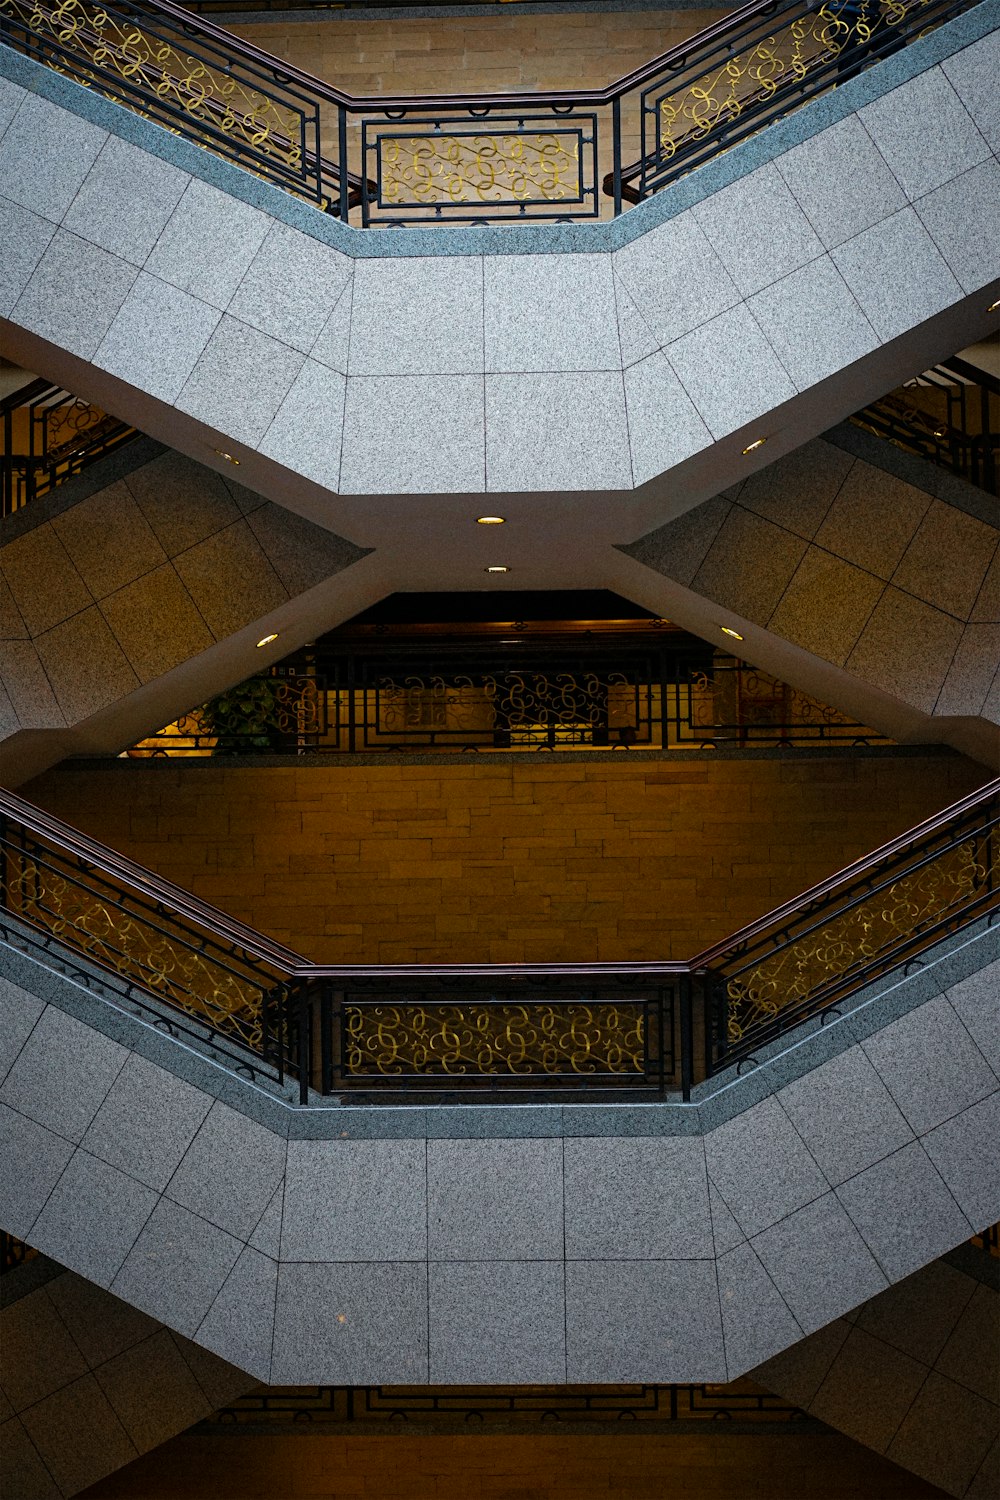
0, 777, 1000, 981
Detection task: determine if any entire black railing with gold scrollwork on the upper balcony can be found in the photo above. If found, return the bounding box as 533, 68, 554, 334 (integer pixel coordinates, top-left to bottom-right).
0, 0, 973, 227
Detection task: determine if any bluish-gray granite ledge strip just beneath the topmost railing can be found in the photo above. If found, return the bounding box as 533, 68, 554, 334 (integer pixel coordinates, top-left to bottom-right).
0, 0, 999, 260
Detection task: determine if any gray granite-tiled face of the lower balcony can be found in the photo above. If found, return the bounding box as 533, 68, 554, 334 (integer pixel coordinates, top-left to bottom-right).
0, 930, 1000, 1392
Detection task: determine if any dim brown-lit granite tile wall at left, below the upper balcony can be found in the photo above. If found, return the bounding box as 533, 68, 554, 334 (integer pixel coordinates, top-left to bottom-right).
0, 444, 364, 744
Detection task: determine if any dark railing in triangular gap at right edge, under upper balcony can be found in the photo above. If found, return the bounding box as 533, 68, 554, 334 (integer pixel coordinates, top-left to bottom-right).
852, 356, 1000, 495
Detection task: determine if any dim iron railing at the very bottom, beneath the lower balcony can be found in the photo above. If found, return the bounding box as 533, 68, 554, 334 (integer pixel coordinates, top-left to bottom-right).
202, 1379, 817, 1433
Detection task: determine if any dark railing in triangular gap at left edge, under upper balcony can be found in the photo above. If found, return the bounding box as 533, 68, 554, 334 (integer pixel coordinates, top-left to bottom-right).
0, 380, 139, 516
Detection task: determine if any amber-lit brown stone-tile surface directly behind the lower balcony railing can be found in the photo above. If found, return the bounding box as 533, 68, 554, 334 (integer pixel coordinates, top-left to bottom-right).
24, 753, 987, 963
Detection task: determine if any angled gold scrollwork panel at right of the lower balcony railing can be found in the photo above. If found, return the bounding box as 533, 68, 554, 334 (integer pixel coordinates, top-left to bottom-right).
727, 840, 1000, 1044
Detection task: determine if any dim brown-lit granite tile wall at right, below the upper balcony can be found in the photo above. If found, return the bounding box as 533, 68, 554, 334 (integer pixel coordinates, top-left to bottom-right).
622, 423, 1000, 732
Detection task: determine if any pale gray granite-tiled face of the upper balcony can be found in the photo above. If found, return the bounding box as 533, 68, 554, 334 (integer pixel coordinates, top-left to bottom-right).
0, 18, 1000, 512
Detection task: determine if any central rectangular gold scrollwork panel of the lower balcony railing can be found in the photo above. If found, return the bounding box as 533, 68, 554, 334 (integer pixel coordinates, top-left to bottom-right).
343, 1002, 645, 1077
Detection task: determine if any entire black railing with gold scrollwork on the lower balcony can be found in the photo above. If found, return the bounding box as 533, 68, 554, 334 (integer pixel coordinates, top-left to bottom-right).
0, 780, 1000, 1104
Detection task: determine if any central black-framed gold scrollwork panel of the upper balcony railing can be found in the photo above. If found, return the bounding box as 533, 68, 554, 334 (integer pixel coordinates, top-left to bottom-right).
361, 113, 600, 225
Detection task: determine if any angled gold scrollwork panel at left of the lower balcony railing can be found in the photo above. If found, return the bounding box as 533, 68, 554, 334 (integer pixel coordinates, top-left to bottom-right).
4, 854, 262, 1052
